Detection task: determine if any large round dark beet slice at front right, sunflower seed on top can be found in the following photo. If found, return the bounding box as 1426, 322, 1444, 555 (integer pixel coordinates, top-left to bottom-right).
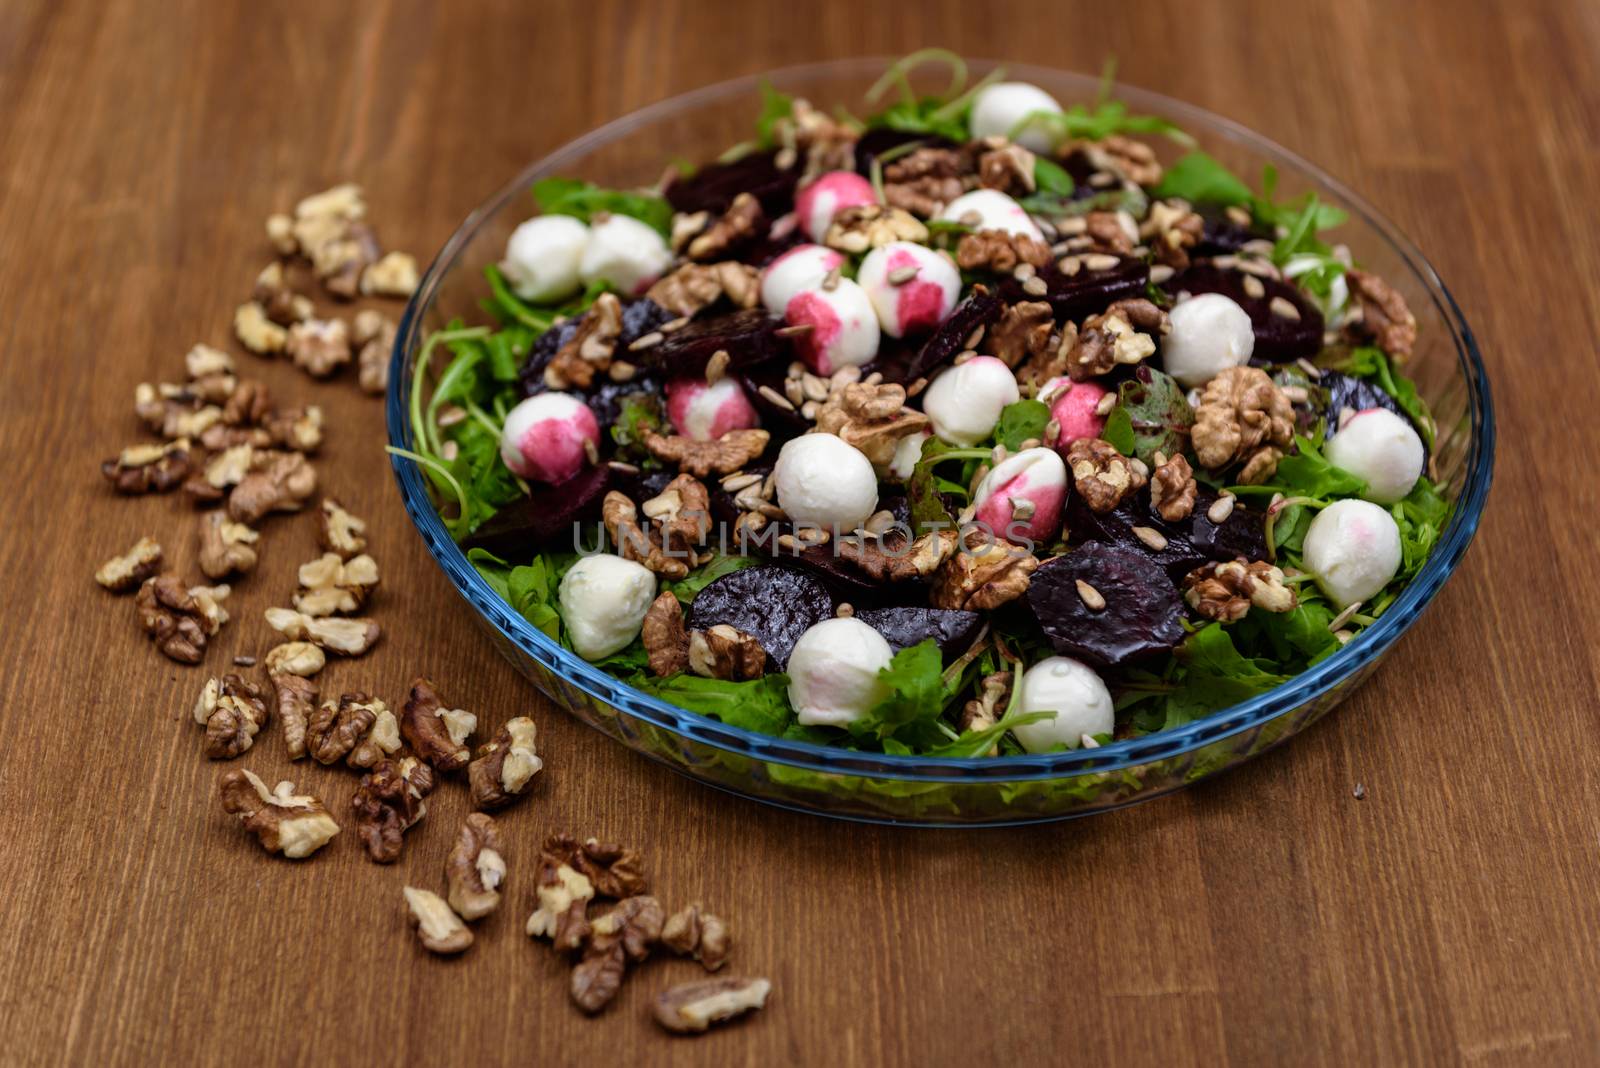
1027, 542, 1184, 667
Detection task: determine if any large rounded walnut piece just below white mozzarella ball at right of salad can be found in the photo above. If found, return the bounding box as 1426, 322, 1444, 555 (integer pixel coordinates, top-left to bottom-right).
1190, 368, 1294, 486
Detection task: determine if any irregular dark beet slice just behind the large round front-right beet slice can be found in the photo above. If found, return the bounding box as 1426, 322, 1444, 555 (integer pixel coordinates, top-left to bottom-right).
1067, 488, 1267, 582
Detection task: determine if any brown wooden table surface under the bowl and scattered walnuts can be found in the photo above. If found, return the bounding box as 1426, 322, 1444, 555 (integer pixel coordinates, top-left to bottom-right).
0, 0, 1600, 1065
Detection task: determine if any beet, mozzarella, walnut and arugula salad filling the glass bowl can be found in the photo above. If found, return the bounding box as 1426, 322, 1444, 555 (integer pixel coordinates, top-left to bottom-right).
390, 53, 1488, 820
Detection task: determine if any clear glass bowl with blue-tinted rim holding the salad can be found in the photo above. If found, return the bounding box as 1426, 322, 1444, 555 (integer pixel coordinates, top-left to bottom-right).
380, 59, 1494, 825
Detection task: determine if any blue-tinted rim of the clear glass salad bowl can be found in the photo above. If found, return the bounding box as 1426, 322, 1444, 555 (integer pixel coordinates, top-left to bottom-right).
387, 58, 1494, 785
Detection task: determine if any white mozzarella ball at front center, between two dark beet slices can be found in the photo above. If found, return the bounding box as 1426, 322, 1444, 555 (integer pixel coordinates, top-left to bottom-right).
786, 619, 894, 727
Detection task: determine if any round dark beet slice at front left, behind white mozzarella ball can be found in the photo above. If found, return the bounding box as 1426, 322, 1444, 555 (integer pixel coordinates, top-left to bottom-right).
688, 564, 834, 667
